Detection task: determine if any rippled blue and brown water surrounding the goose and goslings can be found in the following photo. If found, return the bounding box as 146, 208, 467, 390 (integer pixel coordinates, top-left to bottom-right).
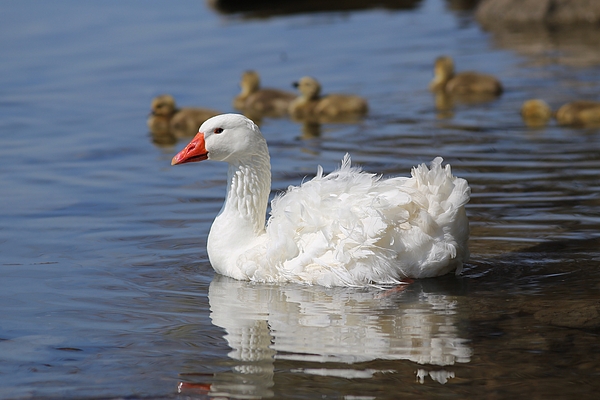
0, 0, 600, 399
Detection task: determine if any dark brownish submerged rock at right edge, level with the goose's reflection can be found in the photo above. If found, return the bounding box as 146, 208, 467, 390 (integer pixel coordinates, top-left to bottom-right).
533, 300, 600, 329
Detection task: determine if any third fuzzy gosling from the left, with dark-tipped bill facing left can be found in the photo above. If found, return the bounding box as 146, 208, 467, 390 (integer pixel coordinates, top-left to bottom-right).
289, 76, 369, 122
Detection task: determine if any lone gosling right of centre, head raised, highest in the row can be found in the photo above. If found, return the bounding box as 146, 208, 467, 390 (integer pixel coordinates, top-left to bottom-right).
429, 56, 503, 96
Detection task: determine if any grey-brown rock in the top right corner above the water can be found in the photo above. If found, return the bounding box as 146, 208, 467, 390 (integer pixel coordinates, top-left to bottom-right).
476, 0, 600, 27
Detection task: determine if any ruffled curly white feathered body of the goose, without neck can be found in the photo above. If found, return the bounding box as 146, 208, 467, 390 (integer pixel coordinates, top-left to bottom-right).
238, 157, 470, 286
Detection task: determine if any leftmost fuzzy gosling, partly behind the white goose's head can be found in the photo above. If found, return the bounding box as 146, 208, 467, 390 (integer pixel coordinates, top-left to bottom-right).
147, 94, 220, 137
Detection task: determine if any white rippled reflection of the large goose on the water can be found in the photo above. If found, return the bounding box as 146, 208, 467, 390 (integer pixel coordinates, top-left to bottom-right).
199, 276, 471, 397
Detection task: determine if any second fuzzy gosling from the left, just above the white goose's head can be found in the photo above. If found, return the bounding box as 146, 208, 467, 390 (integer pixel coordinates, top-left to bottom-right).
233, 71, 296, 117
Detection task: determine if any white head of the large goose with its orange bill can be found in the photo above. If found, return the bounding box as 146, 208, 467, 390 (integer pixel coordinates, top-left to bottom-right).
171, 114, 268, 165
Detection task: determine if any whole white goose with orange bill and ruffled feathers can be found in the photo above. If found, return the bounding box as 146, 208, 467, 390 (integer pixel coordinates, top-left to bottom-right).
172, 114, 470, 286
